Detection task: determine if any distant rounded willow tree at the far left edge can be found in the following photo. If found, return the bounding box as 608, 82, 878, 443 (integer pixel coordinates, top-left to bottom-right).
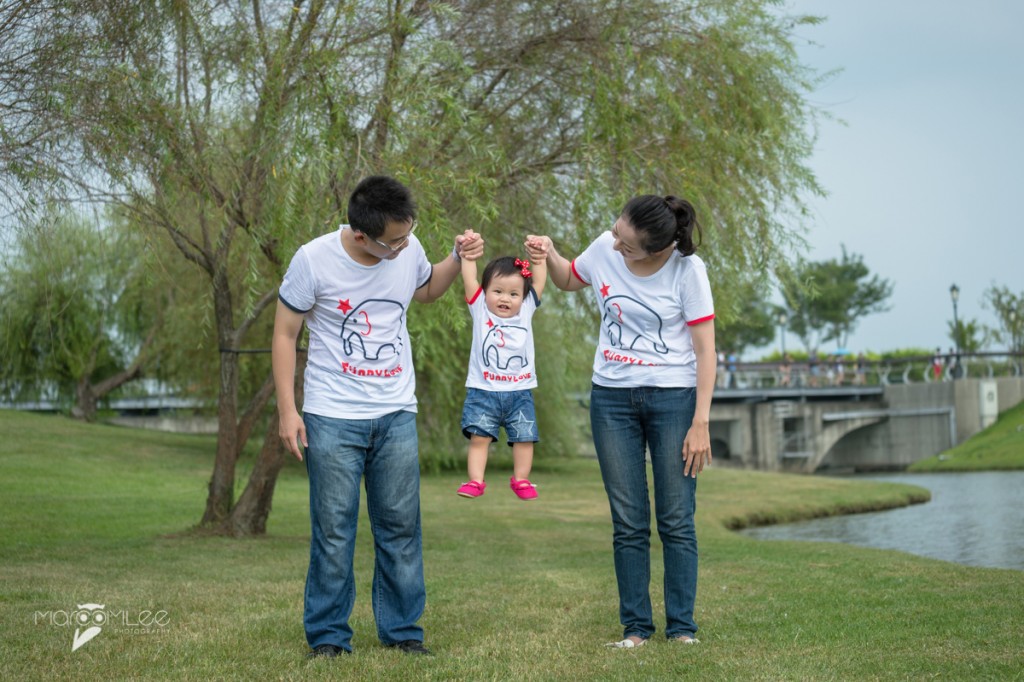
0, 212, 163, 421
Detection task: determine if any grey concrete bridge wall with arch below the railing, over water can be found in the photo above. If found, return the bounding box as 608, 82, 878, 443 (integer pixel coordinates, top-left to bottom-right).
711, 376, 1024, 473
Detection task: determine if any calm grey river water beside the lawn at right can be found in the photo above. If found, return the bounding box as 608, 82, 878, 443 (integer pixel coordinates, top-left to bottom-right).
740, 471, 1024, 570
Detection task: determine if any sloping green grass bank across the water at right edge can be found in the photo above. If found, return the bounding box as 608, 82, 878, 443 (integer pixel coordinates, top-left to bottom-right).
907, 402, 1024, 466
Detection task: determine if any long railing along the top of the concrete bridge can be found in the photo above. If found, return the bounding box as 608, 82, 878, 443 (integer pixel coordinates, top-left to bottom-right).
716, 351, 1024, 389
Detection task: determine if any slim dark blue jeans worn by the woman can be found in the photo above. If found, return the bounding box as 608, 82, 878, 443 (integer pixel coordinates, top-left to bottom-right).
590, 385, 697, 639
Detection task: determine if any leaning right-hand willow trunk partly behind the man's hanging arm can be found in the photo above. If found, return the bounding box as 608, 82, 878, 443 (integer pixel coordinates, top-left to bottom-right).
222, 351, 306, 538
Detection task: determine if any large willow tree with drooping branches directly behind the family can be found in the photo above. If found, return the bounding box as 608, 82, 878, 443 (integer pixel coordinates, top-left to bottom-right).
6, 0, 817, 532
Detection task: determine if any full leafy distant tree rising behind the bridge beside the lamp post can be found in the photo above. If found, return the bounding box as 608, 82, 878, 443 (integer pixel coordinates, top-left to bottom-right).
781, 246, 893, 350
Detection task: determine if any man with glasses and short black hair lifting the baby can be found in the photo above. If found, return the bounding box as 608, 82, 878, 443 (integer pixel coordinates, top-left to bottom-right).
272, 176, 483, 657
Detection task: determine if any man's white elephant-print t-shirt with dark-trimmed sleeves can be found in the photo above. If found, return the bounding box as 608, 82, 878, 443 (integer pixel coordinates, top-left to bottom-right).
279, 225, 432, 419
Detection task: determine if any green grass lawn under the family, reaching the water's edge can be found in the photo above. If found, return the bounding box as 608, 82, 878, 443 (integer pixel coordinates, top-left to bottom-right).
0, 405, 1024, 682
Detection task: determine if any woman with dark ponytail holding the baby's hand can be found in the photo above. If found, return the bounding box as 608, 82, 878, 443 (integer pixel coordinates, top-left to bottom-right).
526, 195, 717, 648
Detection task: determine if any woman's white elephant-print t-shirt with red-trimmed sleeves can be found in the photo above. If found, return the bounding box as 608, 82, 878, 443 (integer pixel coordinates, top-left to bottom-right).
572, 231, 715, 388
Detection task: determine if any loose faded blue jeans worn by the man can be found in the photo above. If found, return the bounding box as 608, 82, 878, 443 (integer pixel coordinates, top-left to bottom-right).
303, 412, 426, 651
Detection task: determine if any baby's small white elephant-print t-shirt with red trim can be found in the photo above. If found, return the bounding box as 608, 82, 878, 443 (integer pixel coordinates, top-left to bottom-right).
466, 289, 541, 391
